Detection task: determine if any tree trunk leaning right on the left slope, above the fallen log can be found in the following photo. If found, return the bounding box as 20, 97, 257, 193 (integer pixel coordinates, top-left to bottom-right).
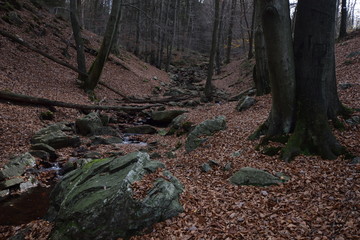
84, 0, 121, 91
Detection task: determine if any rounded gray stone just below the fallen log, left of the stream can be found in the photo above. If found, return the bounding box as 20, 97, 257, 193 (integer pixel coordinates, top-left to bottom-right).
75, 112, 104, 136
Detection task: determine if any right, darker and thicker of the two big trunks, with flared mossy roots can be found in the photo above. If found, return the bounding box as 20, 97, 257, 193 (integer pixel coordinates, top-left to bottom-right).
282, 0, 343, 161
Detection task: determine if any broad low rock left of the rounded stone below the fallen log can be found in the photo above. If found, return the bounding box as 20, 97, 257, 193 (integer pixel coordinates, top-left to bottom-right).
30, 123, 80, 149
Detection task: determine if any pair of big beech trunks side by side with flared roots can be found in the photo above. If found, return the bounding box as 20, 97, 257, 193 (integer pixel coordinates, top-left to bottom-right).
253, 0, 344, 161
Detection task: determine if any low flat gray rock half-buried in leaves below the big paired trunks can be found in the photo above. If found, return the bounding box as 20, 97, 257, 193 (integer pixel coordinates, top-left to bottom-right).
230, 167, 282, 187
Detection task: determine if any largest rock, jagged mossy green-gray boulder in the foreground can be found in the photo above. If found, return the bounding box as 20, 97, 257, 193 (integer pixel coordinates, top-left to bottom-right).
47, 152, 183, 240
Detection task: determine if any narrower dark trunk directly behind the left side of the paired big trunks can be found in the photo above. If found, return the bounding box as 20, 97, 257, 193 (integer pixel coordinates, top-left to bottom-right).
253, 0, 270, 96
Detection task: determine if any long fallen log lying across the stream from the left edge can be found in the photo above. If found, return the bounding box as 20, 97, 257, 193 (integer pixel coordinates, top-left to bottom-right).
0, 91, 159, 111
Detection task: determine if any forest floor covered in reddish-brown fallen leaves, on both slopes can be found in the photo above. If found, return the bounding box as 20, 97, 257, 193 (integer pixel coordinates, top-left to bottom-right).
0, 0, 360, 240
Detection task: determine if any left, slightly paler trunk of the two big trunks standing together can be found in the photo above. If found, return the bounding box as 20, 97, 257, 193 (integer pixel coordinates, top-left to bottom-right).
260, 0, 295, 136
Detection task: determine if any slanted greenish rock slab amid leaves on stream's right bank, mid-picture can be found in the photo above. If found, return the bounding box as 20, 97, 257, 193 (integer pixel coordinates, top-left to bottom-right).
185, 116, 226, 152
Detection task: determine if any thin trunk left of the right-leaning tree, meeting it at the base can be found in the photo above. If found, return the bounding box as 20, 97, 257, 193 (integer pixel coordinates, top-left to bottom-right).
70, 0, 87, 82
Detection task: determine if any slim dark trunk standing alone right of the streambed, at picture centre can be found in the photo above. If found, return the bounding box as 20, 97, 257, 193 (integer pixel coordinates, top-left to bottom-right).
204, 0, 220, 100
